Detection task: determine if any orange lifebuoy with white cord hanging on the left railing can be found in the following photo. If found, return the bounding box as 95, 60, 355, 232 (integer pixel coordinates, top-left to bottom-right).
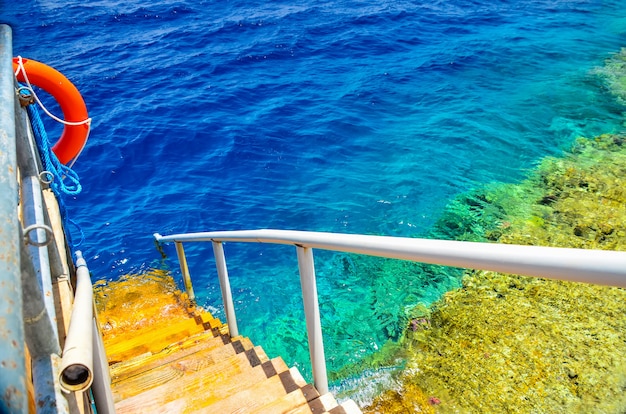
13, 58, 89, 164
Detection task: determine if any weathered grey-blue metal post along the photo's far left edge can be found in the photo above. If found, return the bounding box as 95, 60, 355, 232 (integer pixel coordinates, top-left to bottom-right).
0, 24, 28, 412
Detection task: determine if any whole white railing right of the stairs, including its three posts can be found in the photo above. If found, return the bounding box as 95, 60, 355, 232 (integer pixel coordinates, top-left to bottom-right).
154, 230, 626, 394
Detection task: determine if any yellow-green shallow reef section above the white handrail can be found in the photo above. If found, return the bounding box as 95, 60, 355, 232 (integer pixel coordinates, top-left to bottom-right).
499, 134, 626, 250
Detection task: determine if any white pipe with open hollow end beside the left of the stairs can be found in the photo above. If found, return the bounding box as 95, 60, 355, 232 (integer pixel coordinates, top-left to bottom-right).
59, 251, 93, 392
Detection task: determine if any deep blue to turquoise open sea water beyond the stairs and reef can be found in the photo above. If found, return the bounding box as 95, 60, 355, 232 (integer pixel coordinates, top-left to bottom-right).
0, 0, 626, 392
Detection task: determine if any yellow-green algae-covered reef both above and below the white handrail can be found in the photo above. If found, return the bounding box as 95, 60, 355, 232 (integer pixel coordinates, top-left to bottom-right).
356, 49, 626, 413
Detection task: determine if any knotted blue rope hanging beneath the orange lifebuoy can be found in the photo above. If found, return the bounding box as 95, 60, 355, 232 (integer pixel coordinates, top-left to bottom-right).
27, 105, 85, 252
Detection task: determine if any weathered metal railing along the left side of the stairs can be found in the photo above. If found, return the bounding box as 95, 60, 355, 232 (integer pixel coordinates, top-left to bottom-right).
0, 24, 114, 413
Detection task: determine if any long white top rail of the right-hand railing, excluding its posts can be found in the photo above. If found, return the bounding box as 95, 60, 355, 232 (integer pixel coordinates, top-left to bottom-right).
154, 230, 626, 287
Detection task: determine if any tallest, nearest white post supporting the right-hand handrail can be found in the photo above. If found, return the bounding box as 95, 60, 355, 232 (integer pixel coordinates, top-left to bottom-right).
296, 246, 328, 395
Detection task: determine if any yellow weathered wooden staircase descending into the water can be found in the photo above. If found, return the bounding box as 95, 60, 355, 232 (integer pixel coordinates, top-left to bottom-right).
104, 310, 361, 414
